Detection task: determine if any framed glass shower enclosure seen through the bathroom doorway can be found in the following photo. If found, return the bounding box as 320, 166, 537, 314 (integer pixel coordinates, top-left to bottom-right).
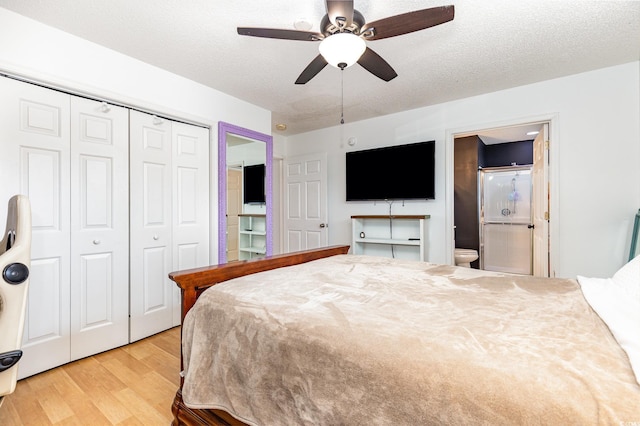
478, 166, 533, 275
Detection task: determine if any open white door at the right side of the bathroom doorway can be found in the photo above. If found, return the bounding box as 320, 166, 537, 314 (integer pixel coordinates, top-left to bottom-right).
532, 123, 549, 277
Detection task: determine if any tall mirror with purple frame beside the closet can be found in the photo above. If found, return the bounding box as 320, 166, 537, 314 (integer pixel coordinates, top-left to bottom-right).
218, 121, 273, 263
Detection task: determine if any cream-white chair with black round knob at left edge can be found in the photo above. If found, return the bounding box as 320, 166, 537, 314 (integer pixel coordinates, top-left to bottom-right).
0, 195, 31, 405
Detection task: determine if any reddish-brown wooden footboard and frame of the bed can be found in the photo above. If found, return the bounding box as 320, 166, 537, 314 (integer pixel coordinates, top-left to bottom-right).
169, 246, 349, 426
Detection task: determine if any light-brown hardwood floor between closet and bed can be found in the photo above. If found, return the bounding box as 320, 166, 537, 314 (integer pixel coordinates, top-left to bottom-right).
0, 327, 180, 426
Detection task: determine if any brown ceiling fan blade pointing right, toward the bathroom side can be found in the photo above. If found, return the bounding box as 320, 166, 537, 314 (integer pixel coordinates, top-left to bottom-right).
360, 5, 454, 40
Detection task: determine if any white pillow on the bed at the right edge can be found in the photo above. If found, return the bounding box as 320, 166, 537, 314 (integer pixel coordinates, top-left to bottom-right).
578, 256, 640, 384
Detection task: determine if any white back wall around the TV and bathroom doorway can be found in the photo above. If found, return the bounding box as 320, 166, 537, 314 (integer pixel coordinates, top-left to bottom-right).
285, 62, 640, 277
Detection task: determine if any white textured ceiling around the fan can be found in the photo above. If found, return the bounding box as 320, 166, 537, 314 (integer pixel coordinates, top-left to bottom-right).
0, 0, 640, 135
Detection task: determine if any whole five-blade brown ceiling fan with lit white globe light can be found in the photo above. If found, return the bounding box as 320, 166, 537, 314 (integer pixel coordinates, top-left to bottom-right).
238, 0, 454, 84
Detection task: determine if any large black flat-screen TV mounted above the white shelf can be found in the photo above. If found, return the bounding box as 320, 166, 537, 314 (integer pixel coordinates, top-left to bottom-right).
346, 141, 436, 201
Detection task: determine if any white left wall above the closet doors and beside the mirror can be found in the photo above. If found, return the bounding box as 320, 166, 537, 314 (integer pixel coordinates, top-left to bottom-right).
0, 8, 271, 259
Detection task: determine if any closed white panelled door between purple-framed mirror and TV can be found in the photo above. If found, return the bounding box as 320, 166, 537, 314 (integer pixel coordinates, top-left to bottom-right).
284, 153, 329, 252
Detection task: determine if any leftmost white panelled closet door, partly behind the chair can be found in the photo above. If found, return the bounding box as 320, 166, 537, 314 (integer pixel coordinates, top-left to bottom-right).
0, 78, 70, 378
